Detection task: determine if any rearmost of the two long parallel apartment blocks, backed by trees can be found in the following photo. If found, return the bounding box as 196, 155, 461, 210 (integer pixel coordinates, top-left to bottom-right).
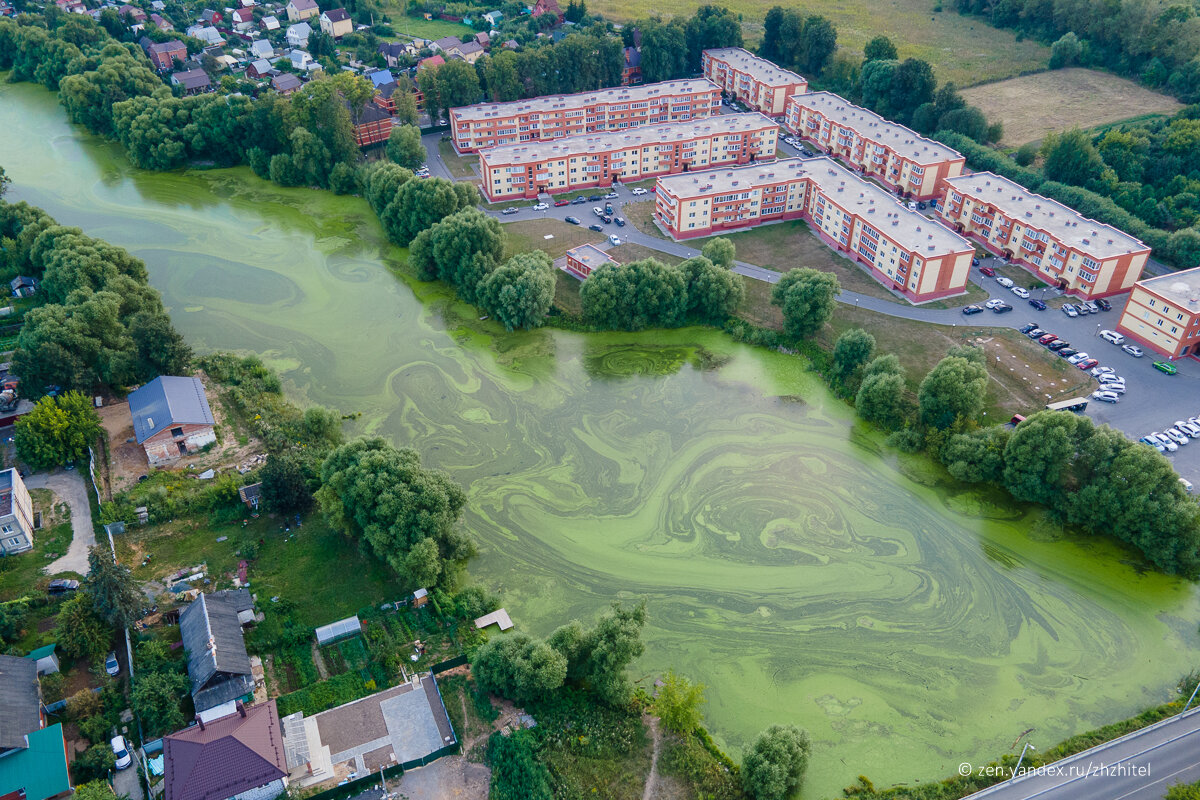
450, 78, 721, 152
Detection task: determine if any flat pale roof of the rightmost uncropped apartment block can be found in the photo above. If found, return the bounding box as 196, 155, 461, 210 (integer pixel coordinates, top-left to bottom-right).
946, 173, 1150, 259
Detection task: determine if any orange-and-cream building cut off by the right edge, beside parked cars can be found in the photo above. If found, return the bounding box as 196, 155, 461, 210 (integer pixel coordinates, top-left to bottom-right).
1117, 266, 1200, 359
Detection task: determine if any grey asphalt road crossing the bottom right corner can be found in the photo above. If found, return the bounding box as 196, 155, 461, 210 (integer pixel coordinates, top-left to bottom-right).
962, 709, 1200, 800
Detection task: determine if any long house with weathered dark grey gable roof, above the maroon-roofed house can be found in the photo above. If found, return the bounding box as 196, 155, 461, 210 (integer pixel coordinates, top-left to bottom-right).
179, 589, 258, 714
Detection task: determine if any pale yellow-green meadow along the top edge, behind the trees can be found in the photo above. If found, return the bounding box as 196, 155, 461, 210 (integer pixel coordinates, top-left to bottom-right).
588, 0, 1050, 86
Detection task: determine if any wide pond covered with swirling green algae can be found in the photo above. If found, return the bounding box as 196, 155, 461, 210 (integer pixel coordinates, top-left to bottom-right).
0, 84, 1200, 798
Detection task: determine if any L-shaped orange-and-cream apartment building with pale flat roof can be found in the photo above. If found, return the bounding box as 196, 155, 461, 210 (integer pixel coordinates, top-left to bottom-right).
654, 157, 974, 302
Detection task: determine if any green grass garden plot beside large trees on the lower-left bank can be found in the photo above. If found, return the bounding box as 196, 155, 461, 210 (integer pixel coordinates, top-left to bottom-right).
116, 515, 402, 625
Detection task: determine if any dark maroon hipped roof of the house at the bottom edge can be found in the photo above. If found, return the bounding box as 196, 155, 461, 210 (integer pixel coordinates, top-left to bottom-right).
162, 700, 287, 800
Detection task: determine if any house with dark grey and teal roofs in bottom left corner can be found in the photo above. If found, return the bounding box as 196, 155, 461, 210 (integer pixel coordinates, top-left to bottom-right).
0, 656, 72, 800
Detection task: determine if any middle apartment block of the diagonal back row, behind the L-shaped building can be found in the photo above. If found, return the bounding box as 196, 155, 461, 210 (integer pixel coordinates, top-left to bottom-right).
784, 91, 966, 200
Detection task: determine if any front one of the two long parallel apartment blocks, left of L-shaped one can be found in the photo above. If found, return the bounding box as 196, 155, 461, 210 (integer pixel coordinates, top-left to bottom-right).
479, 114, 779, 203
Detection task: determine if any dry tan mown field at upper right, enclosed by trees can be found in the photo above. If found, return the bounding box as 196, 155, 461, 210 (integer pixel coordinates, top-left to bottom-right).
962, 67, 1182, 146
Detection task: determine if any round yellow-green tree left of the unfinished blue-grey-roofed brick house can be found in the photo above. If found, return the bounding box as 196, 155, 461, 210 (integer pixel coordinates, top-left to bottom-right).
16, 391, 101, 469
